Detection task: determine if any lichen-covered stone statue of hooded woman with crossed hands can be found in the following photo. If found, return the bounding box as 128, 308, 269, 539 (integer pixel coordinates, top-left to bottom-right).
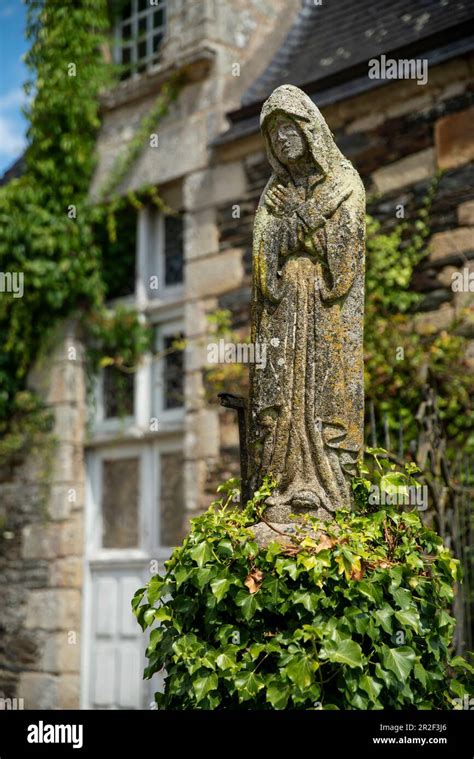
248, 85, 365, 523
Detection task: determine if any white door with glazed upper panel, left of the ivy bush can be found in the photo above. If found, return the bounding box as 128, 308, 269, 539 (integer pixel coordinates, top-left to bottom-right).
82, 443, 181, 709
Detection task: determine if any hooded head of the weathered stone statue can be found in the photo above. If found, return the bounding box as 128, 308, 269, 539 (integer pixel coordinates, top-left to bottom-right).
260, 84, 345, 183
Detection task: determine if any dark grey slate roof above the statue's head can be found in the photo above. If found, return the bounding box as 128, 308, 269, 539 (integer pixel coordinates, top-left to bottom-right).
217, 0, 474, 143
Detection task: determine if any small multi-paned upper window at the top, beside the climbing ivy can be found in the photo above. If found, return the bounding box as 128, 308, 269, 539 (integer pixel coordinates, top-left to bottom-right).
116, 0, 166, 79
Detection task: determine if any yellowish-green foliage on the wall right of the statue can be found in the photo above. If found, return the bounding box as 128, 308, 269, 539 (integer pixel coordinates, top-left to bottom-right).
364, 188, 474, 447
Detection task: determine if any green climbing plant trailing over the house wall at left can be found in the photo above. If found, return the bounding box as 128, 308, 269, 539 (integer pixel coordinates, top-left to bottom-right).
0, 0, 178, 454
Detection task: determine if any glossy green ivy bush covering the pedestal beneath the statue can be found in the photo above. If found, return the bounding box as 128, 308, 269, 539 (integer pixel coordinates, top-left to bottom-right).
132, 472, 474, 709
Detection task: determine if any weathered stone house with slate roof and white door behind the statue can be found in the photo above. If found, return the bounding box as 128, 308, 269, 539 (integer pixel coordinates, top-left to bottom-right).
0, 0, 474, 708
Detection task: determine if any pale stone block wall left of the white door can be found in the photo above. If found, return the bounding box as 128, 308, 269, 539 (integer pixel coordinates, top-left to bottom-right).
0, 323, 85, 709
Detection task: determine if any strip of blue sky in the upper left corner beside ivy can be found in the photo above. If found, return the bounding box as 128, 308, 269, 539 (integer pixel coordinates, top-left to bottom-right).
0, 0, 27, 175
